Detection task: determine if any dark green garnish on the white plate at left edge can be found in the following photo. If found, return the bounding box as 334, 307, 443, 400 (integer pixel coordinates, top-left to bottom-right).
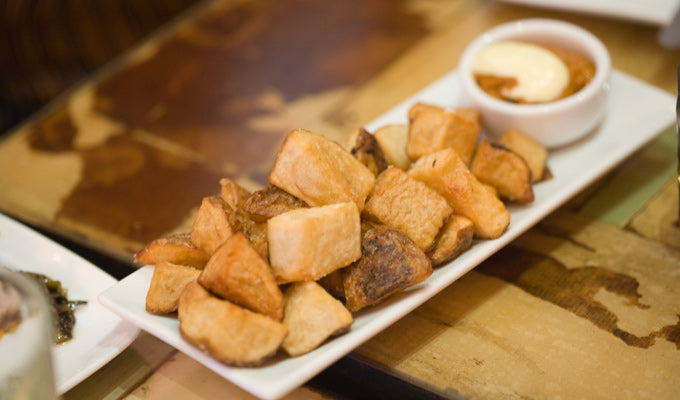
22, 271, 87, 344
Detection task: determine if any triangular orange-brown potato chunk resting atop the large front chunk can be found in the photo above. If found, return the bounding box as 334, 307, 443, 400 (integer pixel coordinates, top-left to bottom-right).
198, 232, 283, 321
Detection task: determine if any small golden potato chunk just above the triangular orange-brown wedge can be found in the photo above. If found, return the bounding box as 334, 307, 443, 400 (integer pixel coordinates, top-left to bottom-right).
191, 196, 240, 255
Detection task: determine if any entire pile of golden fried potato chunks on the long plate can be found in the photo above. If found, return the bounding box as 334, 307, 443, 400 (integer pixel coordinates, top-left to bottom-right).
135, 103, 548, 366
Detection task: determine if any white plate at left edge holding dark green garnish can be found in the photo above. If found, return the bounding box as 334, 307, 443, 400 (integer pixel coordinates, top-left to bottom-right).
0, 214, 139, 395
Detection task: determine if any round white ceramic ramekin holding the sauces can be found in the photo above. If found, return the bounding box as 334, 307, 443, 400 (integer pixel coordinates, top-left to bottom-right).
458, 19, 611, 148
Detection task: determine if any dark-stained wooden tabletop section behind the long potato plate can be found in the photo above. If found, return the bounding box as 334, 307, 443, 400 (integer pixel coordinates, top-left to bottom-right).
0, 0, 674, 260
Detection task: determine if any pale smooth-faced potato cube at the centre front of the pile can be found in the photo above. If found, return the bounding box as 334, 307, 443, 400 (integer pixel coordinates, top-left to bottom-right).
267, 202, 361, 283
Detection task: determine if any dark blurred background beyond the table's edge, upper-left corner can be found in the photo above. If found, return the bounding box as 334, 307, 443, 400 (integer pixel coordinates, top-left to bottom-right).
0, 0, 200, 132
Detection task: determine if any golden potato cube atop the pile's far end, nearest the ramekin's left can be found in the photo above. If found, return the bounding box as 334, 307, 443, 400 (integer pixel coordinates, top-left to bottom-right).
406, 104, 481, 165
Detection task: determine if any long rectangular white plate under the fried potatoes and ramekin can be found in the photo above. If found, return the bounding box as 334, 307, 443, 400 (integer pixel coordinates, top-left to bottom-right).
99, 71, 675, 399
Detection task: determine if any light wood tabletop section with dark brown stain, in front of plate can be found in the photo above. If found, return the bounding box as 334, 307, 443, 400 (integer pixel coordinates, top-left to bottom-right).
358, 213, 680, 399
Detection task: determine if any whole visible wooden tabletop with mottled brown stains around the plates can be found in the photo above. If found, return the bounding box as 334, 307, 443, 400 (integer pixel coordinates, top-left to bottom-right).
0, 0, 680, 399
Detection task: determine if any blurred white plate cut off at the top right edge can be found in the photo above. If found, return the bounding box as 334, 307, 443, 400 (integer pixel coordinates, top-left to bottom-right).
501, 0, 680, 26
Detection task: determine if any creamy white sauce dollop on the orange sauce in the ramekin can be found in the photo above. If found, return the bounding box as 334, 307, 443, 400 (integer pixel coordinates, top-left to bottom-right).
472, 41, 569, 103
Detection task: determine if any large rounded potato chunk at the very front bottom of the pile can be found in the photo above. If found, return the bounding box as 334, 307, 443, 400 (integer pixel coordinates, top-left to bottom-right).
177, 282, 288, 366
